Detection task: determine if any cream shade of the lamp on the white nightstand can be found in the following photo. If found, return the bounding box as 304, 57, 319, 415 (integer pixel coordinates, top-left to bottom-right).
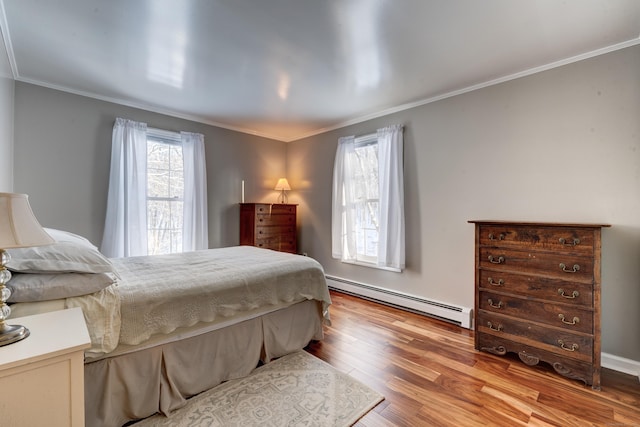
0, 193, 54, 249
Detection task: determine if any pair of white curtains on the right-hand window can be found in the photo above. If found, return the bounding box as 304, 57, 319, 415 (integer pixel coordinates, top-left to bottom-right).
331, 125, 405, 270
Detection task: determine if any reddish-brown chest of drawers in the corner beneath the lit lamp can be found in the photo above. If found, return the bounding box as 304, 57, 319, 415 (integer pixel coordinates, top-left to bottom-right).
240, 203, 297, 253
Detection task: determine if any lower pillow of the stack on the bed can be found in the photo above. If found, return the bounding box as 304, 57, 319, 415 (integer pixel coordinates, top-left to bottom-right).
7, 273, 115, 302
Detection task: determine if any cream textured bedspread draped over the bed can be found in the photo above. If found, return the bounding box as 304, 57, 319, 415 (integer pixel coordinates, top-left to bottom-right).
12, 246, 331, 359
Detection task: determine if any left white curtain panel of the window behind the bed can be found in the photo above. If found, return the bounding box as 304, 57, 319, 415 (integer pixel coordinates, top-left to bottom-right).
100, 118, 147, 258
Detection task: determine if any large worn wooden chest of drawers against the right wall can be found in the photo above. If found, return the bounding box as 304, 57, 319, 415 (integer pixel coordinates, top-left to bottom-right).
469, 221, 607, 390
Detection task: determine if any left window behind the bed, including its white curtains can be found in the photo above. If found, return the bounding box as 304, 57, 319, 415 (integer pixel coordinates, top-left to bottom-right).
100, 117, 209, 258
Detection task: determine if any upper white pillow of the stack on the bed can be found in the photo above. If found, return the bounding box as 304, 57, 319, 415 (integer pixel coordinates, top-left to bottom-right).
7, 242, 115, 273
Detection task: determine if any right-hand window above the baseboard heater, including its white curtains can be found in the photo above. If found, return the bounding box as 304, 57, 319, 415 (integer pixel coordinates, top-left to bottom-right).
332, 126, 405, 271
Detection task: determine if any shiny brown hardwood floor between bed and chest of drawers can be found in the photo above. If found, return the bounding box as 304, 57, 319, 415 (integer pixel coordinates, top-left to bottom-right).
307, 291, 640, 427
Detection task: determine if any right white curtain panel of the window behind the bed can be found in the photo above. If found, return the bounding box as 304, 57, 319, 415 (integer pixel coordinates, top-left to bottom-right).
180, 132, 209, 252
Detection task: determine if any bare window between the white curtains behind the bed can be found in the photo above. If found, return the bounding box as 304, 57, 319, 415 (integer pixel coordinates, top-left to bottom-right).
147, 129, 184, 255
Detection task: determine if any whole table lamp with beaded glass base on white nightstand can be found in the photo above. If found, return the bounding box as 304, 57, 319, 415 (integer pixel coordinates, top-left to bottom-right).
0, 193, 54, 346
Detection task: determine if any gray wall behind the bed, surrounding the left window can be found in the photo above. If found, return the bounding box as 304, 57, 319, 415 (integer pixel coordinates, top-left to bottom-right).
14, 82, 286, 247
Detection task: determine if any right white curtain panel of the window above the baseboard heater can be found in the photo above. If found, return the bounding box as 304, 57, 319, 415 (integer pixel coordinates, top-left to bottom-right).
378, 125, 405, 269
